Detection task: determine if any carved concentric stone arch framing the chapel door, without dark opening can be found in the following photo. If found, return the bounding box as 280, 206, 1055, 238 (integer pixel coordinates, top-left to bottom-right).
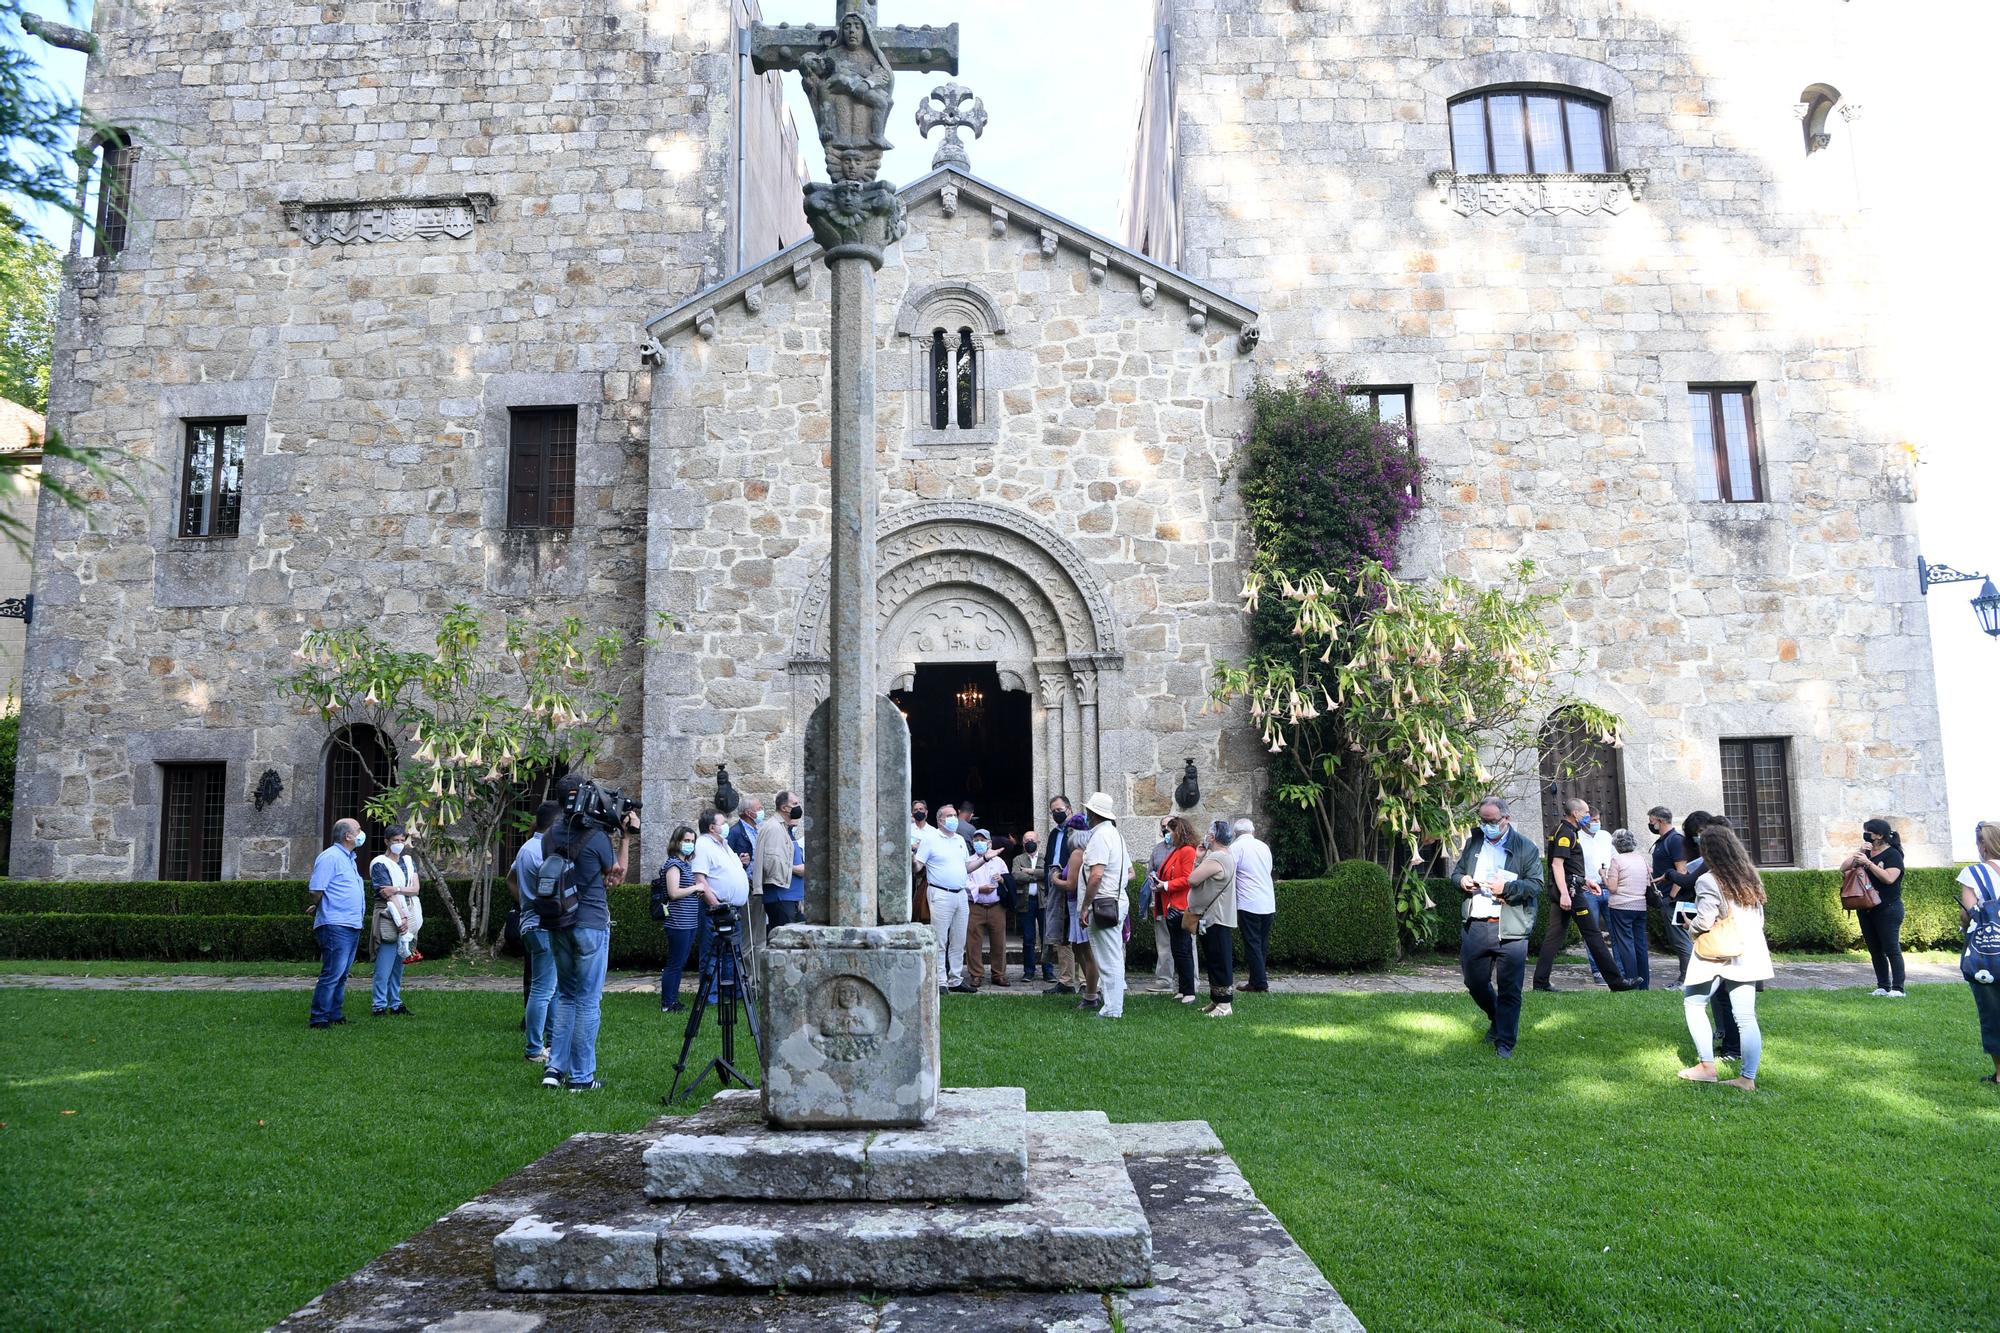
790, 500, 1124, 809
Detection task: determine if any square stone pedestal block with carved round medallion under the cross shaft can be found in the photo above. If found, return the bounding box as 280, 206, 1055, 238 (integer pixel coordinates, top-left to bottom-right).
758, 925, 940, 1129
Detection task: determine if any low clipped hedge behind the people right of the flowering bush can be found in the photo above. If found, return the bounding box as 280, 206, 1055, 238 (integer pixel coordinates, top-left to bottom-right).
1430, 867, 1964, 953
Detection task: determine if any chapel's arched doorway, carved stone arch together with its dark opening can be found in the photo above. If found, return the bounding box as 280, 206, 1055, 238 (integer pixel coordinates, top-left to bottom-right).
790, 500, 1124, 833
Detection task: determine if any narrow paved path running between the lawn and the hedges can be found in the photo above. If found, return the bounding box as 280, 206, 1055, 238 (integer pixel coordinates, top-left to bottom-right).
0, 957, 1960, 997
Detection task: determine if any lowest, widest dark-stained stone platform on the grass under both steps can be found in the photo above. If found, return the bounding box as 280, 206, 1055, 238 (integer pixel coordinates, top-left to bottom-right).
276, 1117, 1362, 1333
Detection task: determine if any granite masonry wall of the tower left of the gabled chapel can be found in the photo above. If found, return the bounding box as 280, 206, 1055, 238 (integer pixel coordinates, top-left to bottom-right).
14, 0, 790, 879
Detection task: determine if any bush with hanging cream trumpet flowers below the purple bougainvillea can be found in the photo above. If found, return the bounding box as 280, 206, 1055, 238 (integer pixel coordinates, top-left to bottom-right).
1214, 560, 1620, 865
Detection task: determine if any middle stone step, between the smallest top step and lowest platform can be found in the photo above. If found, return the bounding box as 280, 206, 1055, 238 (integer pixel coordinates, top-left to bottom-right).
492, 1111, 1152, 1291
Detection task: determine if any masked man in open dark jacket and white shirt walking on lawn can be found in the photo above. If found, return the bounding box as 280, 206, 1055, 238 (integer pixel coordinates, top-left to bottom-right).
1452, 797, 1542, 1059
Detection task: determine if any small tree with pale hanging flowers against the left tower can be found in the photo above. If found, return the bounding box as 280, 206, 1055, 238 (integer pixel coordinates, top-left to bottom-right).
280, 604, 626, 947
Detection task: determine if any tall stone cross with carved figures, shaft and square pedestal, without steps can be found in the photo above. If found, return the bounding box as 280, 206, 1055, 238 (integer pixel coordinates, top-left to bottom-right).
750, 0, 958, 1129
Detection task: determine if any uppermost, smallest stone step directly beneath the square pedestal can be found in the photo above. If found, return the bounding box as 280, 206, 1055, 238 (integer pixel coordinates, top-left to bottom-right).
644, 1087, 1028, 1203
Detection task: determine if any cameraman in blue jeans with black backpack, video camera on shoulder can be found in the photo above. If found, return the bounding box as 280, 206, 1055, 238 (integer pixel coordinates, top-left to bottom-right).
542, 783, 638, 1093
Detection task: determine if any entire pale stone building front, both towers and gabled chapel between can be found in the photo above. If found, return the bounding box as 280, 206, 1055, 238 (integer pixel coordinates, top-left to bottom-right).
14, 0, 1946, 879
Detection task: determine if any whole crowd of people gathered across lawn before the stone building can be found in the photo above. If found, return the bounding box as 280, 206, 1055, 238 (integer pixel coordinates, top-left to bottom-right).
308, 768, 2000, 1091
